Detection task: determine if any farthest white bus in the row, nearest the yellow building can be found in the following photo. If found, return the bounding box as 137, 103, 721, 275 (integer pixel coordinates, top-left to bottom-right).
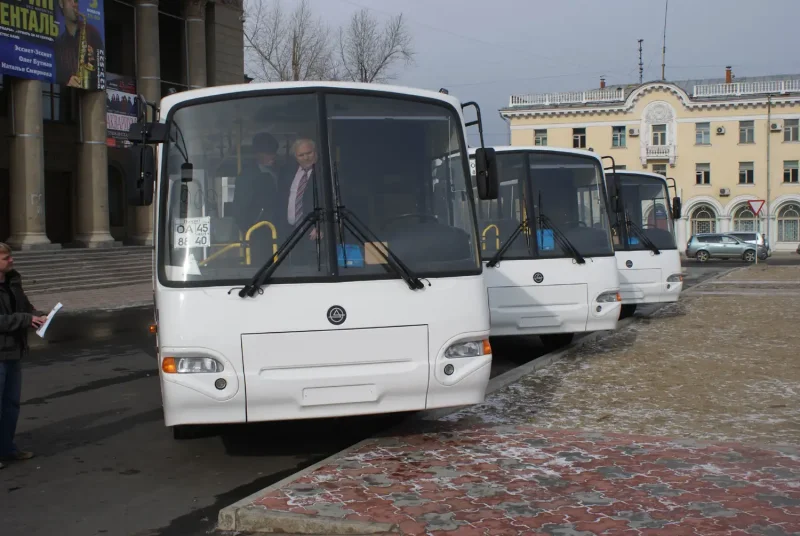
606, 170, 683, 318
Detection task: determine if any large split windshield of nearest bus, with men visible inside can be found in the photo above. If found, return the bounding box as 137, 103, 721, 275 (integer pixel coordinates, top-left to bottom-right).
158, 90, 481, 286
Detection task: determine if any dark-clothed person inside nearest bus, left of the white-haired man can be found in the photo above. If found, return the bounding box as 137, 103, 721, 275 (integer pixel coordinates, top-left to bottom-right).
233, 132, 285, 264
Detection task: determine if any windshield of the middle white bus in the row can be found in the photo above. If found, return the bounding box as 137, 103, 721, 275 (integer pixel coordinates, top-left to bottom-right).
478, 151, 614, 262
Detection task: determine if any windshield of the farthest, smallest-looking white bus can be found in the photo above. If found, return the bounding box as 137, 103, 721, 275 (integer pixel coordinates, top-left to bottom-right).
606, 171, 677, 251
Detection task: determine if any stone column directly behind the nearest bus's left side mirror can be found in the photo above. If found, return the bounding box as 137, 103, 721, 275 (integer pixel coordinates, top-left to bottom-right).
133, 0, 161, 246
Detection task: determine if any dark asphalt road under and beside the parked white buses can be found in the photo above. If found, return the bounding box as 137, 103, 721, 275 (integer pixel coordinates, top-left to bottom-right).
0, 262, 776, 536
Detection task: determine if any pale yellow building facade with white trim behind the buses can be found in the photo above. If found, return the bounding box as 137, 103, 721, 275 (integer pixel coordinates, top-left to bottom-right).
500, 70, 800, 251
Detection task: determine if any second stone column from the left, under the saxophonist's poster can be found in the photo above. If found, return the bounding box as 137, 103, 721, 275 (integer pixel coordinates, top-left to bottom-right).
75, 91, 114, 248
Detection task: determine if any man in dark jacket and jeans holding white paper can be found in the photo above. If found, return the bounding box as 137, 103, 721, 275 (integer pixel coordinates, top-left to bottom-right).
0, 242, 47, 469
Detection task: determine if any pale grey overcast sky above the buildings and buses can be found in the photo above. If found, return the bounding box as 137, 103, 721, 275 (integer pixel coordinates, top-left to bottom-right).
250, 0, 800, 145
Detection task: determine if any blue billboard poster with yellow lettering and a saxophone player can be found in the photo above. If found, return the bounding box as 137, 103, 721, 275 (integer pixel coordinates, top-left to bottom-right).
0, 0, 106, 90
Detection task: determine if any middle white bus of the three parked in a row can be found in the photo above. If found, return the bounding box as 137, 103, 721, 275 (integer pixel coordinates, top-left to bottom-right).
468, 147, 621, 348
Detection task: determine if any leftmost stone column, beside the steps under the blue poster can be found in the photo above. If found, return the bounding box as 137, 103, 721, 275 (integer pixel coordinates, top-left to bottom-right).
8, 78, 61, 249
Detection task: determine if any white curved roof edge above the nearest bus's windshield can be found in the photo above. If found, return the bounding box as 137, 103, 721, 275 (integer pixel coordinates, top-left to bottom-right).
161, 81, 461, 116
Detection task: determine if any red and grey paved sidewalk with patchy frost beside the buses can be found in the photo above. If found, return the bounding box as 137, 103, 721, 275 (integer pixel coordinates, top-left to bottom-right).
220, 266, 800, 536
